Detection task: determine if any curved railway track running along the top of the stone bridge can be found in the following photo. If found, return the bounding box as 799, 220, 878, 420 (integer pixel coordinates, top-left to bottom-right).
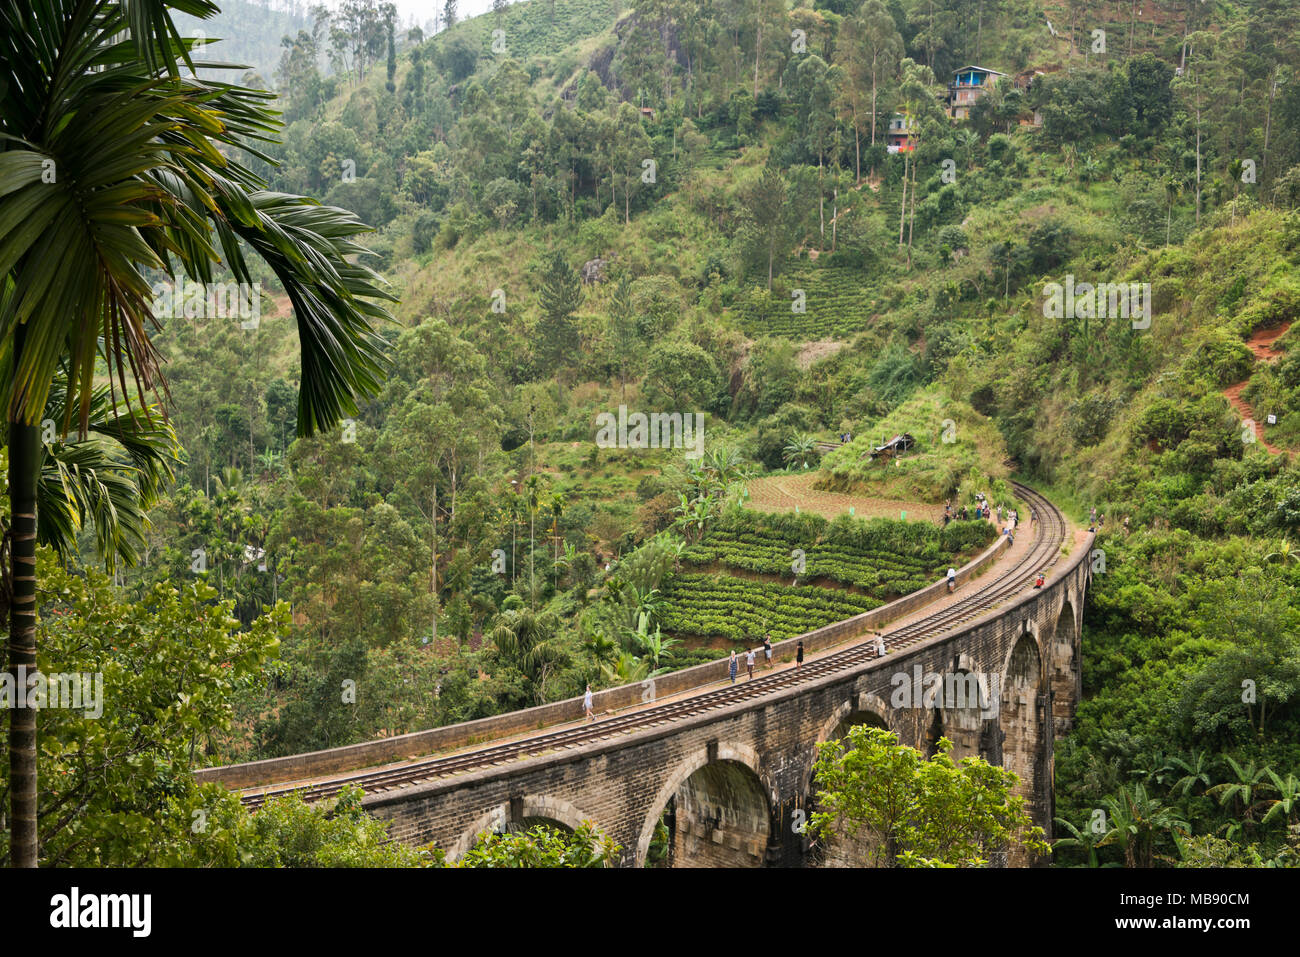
241, 482, 1067, 810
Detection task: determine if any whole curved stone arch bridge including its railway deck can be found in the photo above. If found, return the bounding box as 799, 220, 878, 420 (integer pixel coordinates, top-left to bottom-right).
198, 486, 1092, 866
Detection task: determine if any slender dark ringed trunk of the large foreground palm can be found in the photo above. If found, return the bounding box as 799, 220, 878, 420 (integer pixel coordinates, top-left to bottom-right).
8, 326, 40, 867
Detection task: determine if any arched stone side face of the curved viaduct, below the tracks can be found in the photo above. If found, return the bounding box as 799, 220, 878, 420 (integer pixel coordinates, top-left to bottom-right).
200, 486, 1092, 866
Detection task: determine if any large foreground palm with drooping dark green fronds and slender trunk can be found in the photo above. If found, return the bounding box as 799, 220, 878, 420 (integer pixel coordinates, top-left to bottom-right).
0, 0, 391, 867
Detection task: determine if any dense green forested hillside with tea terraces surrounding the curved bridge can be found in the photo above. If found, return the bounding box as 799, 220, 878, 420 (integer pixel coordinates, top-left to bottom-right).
0, 0, 1300, 866
